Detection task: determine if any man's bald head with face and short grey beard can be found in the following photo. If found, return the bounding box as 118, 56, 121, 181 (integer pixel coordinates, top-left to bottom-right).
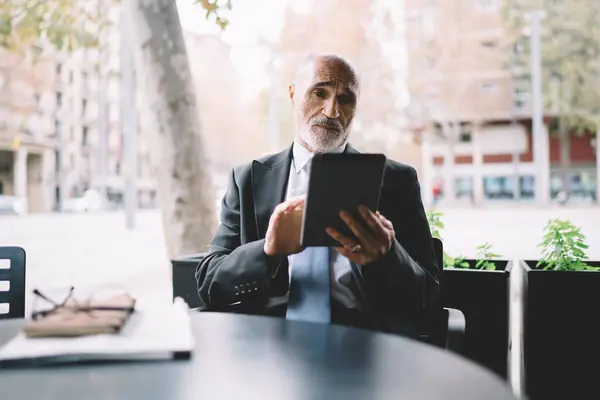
289, 54, 359, 152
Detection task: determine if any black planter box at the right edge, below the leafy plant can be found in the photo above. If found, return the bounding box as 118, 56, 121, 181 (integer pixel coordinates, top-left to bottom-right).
521, 261, 600, 400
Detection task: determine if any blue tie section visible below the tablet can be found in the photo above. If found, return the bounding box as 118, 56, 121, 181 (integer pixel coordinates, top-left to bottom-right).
286, 247, 331, 323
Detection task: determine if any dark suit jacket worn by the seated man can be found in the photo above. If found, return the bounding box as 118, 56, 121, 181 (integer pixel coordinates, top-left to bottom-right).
196, 145, 441, 336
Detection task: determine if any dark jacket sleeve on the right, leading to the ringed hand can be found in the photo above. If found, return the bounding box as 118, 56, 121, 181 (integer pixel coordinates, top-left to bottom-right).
361, 167, 441, 319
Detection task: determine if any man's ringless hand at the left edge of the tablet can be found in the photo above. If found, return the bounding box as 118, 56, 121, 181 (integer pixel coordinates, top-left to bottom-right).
264, 197, 305, 257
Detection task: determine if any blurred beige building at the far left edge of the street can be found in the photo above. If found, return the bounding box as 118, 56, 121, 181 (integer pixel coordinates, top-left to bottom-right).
0, 49, 57, 211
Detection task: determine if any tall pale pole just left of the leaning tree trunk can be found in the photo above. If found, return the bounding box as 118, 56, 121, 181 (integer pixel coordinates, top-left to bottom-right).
120, 0, 138, 229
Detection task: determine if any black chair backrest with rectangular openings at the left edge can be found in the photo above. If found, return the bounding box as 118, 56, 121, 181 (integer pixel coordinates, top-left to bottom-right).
0, 247, 25, 319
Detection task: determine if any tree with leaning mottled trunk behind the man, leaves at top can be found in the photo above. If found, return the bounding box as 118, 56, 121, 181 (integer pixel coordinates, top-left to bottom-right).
0, 0, 231, 257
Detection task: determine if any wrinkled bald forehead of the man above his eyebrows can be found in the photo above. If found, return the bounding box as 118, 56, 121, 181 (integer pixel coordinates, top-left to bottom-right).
301, 59, 359, 96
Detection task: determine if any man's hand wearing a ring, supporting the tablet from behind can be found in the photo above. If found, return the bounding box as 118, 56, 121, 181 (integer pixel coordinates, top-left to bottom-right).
326, 206, 396, 265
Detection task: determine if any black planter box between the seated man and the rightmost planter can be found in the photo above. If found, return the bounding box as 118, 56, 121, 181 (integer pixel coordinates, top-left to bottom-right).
441, 260, 512, 378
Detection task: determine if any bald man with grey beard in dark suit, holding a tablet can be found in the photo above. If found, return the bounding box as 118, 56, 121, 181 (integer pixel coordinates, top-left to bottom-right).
196, 55, 440, 336
